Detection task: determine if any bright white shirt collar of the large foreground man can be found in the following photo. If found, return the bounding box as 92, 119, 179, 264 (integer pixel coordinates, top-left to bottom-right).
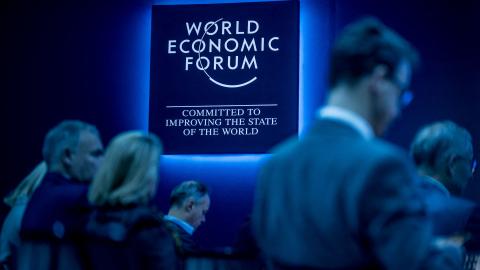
317, 105, 374, 139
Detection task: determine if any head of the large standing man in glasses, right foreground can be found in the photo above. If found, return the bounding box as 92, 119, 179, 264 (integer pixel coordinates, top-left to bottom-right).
328, 17, 418, 135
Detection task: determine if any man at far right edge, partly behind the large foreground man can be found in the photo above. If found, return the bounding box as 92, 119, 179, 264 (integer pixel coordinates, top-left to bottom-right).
410, 121, 480, 249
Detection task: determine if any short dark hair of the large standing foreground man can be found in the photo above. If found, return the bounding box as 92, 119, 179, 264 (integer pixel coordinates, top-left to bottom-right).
328, 17, 419, 88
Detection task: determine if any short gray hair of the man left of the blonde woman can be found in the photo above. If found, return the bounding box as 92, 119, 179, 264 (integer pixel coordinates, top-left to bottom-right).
42, 120, 100, 170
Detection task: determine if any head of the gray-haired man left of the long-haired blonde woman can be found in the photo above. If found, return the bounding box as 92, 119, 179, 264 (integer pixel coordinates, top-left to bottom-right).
42, 120, 103, 181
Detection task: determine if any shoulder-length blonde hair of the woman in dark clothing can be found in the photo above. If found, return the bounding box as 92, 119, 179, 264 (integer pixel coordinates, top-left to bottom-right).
88, 131, 162, 206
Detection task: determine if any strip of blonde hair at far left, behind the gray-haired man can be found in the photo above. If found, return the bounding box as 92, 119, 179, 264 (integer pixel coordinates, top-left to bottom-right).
3, 161, 47, 207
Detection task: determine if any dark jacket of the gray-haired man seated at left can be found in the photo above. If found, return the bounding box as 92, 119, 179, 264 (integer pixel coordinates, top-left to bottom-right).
20, 173, 91, 238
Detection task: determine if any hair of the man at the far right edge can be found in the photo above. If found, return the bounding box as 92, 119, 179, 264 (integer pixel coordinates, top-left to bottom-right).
410, 121, 472, 173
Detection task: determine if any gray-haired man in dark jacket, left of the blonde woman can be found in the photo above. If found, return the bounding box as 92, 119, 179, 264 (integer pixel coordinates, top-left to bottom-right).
20, 120, 103, 239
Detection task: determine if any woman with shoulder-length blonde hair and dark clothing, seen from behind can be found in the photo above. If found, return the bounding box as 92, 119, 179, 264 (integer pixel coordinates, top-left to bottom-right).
87, 131, 176, 269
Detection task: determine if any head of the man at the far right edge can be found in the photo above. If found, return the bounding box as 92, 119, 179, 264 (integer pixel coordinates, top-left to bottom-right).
410, 121, 476, 195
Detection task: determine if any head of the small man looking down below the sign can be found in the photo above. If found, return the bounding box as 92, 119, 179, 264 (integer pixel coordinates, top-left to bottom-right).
168, 181, 210, 229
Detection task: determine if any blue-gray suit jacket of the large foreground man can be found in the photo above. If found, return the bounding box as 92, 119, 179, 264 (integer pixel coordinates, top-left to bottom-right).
252, 119, 461, 269
